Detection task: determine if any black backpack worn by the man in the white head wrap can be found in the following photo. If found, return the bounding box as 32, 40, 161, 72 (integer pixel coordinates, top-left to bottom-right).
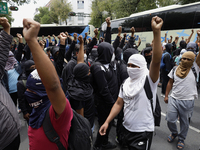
144, 77, 161, 126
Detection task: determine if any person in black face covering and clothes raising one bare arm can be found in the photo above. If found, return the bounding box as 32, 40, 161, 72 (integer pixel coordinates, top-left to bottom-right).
66, 36, 95, 128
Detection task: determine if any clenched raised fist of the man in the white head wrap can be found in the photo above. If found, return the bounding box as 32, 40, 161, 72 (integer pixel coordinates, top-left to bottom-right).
151, 16, 163, 33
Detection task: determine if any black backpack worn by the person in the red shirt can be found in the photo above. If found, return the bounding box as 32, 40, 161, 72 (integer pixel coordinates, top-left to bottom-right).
42, 109, 93, 150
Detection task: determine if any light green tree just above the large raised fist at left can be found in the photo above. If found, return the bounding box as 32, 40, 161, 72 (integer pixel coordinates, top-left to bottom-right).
34, 7, 58, 24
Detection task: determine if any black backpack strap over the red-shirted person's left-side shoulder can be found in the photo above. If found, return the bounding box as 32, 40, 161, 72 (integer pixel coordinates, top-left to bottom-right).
42, 107, 66, 150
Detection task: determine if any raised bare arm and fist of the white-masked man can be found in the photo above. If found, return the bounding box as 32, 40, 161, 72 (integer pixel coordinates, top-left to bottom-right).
149, 16, 163, 83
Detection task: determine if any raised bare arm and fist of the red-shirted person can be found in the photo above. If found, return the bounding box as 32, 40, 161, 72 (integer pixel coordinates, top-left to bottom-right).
23, 19, 66, 117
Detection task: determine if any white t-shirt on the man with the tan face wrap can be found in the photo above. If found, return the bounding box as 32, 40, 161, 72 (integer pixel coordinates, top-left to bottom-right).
168, 62, 200, 100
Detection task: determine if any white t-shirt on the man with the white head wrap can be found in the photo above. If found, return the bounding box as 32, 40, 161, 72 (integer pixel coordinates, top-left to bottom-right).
119, 75, 159, 132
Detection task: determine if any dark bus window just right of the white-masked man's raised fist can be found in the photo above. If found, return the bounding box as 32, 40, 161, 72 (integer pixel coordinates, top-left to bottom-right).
164, 6, 196, 30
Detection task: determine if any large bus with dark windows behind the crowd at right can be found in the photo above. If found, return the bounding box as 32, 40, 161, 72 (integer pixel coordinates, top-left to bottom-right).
100, 2, 200, 50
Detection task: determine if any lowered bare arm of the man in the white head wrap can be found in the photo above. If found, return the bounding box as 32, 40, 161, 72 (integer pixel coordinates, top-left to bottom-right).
99, 97, 124, 135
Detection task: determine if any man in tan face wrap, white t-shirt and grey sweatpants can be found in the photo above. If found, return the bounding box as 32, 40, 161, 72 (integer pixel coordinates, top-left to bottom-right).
164, 42, 200, 149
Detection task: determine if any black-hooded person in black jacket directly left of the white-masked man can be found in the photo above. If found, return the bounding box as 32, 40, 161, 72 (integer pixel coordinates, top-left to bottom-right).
90, 42, 118, 150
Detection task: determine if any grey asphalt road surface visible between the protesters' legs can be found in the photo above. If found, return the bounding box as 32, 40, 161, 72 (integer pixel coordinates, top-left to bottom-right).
19, 88, 200, 150
